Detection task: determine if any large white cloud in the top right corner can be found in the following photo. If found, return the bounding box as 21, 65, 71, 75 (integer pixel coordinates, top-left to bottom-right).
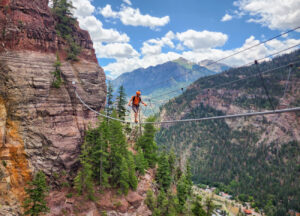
234, 0, 300, 30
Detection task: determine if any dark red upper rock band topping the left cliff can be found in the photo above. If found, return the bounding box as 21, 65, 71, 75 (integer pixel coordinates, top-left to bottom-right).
0, 0, 97, 63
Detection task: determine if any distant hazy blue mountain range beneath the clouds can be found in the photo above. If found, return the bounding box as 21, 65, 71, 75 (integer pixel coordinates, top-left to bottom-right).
112, 58, 229, 95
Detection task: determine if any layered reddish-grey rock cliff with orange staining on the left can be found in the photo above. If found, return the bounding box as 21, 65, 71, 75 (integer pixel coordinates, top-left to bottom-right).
0, 0, 106, 215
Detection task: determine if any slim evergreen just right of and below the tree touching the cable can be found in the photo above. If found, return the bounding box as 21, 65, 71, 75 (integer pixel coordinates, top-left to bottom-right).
156, 152, 172, 191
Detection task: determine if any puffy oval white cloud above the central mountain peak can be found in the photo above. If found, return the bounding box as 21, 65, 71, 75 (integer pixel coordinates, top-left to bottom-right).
176, 29, 228, 50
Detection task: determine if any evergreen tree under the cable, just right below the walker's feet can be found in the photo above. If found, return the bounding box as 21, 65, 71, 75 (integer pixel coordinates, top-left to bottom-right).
136, 117, 157, 168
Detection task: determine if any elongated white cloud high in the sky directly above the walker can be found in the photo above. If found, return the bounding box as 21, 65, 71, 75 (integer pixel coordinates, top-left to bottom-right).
99, 4, 170, 29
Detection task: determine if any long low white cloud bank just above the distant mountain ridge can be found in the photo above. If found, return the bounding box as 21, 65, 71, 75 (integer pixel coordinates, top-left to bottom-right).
104, 36, 300, 78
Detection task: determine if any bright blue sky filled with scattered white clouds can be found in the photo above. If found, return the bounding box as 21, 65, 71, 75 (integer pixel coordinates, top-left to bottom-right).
72, 0, 300, 78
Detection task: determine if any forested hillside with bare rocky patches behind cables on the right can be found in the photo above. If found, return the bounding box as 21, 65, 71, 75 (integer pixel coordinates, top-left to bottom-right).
157, 50, 300, 215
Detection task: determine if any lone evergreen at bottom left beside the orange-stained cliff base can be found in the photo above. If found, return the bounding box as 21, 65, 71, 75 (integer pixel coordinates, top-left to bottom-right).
24, 171, 49, 216
